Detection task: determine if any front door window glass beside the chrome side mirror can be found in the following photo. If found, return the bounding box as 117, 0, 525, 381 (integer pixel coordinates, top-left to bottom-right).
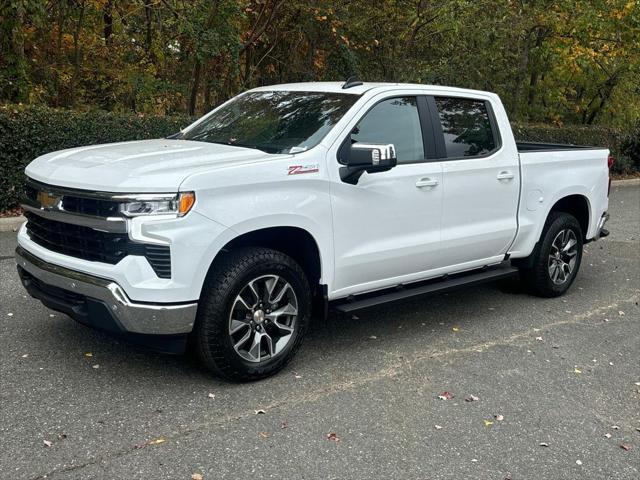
351, 97, 424, 163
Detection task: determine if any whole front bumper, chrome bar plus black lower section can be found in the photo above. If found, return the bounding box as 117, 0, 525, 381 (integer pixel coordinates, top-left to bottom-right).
16, 246, 198, 344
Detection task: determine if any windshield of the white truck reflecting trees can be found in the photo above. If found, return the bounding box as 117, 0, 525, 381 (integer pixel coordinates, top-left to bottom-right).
178, 91, 359, 153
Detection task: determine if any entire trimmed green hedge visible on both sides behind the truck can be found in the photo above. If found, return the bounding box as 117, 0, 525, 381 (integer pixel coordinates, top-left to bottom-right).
0, 105, 640, 212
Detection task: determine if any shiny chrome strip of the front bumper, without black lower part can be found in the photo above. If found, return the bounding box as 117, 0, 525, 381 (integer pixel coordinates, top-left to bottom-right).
16, 246, 198, 335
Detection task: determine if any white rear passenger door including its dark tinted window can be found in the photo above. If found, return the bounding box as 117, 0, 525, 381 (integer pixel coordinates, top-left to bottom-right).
428, 96, 520, 270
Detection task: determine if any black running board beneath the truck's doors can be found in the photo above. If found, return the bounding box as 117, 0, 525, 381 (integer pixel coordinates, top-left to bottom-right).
332, 262, 518, 313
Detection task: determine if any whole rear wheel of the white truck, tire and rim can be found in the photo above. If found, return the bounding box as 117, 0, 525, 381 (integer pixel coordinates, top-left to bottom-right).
520, 212, 583, 297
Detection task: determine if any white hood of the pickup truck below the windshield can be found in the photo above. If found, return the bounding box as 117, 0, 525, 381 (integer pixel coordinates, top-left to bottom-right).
25, 139, 289, 193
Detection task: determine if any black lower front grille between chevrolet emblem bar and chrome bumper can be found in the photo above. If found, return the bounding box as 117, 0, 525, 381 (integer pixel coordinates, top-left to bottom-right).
25, 212, 171, 278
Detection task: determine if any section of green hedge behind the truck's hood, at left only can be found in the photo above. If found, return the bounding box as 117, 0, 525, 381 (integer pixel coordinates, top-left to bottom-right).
0, 105, 193, 212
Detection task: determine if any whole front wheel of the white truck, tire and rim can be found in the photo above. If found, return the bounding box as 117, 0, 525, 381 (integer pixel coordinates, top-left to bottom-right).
194, 248, 311, 381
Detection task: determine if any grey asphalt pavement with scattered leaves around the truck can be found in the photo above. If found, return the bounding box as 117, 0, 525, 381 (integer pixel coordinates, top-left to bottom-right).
0, 187, 640, 480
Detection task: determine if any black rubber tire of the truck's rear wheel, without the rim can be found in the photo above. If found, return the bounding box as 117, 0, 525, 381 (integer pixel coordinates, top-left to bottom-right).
520, 212, 584, 298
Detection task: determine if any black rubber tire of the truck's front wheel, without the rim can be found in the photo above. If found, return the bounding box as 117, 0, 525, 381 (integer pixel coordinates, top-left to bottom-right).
193, 247, 311, 382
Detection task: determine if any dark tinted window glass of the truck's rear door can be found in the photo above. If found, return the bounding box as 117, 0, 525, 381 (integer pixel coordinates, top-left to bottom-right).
435, 97, 496, 158
